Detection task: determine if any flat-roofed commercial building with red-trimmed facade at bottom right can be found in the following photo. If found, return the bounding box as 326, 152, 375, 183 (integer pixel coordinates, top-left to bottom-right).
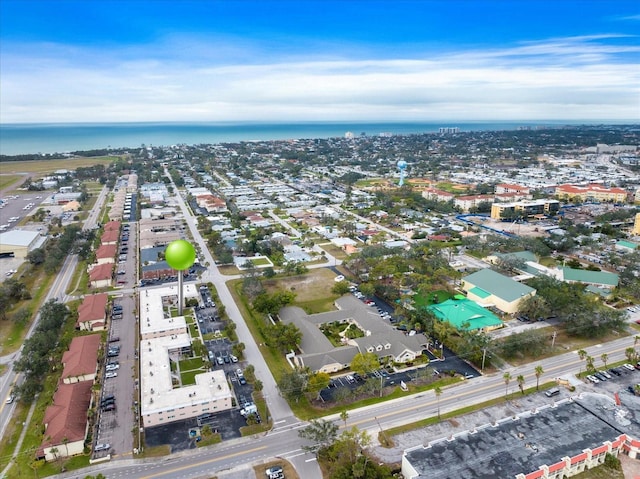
402, 393, 640, 479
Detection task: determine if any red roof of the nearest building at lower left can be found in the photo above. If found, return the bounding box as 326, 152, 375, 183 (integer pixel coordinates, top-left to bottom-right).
40, 381, 93, 449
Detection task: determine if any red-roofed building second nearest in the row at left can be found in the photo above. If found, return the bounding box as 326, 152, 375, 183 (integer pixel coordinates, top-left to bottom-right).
60, 334, 102, 384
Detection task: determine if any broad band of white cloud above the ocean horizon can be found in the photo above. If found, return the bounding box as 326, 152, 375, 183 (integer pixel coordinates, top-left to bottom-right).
0, 35, 640, 123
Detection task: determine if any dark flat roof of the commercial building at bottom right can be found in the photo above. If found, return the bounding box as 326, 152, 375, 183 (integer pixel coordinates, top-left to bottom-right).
405, 395, 624, 479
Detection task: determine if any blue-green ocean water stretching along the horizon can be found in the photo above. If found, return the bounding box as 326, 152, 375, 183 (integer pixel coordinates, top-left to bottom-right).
0, 121, 620, 155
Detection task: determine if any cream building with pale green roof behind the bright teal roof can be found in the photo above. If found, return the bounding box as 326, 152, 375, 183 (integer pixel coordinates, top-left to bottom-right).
462, 269, 536, 314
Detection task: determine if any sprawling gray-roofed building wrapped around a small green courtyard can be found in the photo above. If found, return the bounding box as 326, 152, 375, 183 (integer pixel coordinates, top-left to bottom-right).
279, 295, 427, 373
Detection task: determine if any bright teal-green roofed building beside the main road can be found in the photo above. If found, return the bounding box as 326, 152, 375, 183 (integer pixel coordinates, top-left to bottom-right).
427, 298, 503, 331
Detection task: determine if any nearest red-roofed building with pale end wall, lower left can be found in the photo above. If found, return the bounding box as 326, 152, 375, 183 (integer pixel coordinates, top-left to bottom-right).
36, 381, 93, 461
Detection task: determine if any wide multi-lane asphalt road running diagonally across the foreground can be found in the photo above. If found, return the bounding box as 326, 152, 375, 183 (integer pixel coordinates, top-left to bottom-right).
47, 337, 640, 479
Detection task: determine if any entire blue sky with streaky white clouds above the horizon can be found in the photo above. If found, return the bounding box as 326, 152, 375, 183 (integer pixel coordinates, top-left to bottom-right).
0, 0, 640, 123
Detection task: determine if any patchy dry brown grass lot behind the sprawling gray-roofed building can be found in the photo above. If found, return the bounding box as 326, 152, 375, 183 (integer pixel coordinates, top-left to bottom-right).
262, 268, 339, 314
